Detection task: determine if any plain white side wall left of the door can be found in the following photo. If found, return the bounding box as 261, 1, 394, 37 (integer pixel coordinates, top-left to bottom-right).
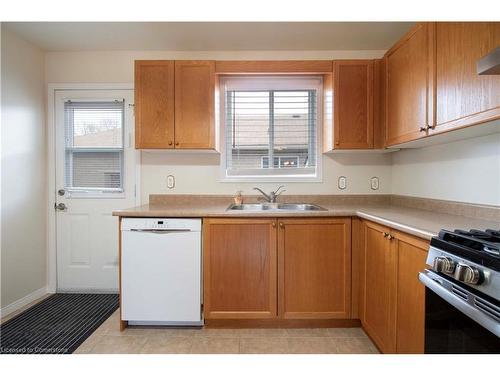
1, 27, 47, 308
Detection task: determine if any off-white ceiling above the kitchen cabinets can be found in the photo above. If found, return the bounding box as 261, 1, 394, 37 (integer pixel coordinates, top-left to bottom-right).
2, 22, 414, 51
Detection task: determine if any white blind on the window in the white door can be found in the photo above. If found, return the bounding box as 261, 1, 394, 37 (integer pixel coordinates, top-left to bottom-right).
64, 100, 124, 192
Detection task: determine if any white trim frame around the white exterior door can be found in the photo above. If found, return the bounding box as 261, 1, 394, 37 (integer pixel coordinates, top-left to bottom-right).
47, 83, 141, 293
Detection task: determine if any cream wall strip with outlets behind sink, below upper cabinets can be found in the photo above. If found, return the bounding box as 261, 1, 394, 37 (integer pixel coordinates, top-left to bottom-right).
141, 152, 391, 202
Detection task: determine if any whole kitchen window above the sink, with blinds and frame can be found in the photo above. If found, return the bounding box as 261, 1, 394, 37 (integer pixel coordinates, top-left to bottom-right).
221, 76, 322, 181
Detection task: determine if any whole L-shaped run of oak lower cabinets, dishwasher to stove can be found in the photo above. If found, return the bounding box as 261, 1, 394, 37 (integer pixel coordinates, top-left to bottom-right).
203, 218, 429, 353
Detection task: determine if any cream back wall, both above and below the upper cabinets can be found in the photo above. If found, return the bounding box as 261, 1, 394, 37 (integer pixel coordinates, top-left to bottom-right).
46, 51, 391, 202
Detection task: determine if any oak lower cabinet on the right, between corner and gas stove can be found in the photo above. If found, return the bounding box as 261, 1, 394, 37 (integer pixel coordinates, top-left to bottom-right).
360, 221, 429, 353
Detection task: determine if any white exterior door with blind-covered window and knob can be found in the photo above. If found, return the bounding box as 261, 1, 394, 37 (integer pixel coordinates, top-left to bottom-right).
55, 90, 138, 291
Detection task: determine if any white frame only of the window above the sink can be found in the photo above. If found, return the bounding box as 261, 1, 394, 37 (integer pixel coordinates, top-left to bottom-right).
218, 75, 324, 182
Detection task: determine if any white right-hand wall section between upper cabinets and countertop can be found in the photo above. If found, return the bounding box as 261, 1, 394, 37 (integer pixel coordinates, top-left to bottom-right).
392, 134, 500, 206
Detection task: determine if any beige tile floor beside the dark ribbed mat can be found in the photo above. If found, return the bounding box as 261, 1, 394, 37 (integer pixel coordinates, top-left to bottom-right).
75, 311, 378, 354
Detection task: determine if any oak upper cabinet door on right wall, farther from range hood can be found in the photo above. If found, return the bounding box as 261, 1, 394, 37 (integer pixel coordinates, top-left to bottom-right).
385, 23, 434, 146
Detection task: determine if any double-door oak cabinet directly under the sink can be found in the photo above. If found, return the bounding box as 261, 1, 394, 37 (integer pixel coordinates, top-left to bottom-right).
203, 218, 351, 320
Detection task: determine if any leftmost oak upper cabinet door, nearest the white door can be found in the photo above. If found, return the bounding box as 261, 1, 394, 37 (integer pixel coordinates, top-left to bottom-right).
135, 60, 174, 149
